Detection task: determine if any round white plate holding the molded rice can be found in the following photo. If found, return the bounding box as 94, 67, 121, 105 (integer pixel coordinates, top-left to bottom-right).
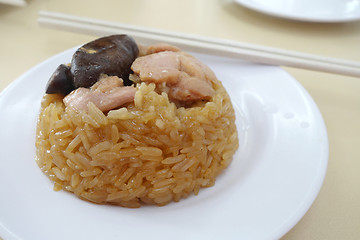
0, 49, 328, 240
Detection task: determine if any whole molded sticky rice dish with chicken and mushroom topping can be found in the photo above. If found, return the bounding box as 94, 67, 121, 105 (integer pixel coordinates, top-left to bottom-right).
36, 35, 238, 207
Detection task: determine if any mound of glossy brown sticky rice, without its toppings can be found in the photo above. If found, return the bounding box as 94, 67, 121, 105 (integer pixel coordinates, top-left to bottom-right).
36, 78, 238, 207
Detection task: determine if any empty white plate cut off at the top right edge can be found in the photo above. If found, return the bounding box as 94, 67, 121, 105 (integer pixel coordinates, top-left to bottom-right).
235, 0, 360, 22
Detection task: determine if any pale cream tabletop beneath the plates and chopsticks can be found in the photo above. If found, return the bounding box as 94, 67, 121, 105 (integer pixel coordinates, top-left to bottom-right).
0, 0, 360, 240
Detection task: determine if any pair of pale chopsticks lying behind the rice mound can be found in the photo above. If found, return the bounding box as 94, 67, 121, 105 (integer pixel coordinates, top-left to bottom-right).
38, 11, 360, 77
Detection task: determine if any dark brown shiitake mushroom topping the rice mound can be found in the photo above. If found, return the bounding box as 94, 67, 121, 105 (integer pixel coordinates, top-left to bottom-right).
46, 34, 139, 95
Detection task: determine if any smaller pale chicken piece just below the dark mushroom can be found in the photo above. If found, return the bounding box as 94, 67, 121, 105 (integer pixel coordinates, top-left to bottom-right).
63, 76, 136, 112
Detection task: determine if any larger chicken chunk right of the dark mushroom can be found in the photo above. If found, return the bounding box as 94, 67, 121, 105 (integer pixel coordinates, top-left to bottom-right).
131, 51, 216, 103
